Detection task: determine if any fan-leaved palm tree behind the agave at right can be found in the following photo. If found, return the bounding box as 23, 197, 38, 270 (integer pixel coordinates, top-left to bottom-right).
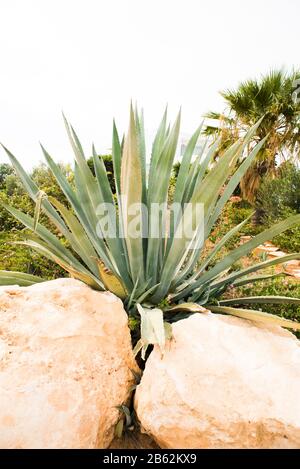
204, 70, 300, 203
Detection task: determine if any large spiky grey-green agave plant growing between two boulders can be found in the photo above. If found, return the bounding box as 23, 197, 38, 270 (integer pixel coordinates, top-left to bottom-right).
0, 107, 300, 356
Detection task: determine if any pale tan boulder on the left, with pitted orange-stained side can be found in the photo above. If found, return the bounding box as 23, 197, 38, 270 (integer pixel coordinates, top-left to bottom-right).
0, 279, 136, 448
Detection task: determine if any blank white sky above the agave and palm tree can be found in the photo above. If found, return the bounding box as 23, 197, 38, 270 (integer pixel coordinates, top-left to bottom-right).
0, 0, 300, 168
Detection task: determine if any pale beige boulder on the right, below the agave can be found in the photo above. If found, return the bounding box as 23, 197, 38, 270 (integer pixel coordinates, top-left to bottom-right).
135, 313, 300, 448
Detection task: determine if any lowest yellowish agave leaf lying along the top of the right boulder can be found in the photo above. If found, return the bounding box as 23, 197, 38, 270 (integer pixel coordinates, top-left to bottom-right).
208, 305, 300, 330
